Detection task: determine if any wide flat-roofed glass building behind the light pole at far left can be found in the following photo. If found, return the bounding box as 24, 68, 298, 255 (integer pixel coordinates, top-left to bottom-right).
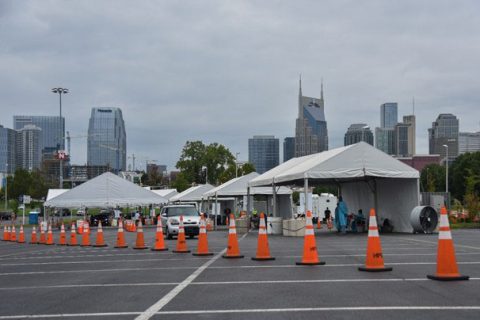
13, 116, 65, 153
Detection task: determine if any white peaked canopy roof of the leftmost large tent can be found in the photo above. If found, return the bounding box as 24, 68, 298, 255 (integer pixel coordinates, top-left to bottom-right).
44, 172, 167, 208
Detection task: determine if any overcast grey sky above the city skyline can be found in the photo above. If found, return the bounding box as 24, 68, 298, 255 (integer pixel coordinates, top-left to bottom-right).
0, 0, 480, 170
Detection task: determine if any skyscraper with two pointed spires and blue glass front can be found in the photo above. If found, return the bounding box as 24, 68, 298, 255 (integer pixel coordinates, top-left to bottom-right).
295, 79, 328, 157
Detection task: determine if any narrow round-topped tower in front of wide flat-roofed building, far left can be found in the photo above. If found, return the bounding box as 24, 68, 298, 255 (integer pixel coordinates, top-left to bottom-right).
15, 124, 44, 171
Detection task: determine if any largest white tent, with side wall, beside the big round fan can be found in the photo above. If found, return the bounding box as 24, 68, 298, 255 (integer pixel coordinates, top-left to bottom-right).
249, 142, 419, 232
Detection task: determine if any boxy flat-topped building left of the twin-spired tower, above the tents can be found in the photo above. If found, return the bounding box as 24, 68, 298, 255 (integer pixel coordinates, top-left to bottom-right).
248, 136, 280, 174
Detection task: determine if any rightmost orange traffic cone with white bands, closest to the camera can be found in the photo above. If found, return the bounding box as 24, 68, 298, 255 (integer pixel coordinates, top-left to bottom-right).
427, 207, 469, 281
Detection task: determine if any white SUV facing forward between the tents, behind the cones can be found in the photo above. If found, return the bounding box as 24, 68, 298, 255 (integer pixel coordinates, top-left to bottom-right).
160, 204, 200, 239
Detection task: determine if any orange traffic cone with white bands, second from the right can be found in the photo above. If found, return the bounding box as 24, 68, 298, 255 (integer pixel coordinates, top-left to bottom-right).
358, 208, 392, 272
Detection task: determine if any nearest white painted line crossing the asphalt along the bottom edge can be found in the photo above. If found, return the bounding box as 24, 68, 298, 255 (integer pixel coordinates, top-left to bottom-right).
0, 306, 480, 320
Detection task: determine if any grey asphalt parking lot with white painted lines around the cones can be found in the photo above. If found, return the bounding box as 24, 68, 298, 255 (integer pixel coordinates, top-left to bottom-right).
0, 228, 480, 320
